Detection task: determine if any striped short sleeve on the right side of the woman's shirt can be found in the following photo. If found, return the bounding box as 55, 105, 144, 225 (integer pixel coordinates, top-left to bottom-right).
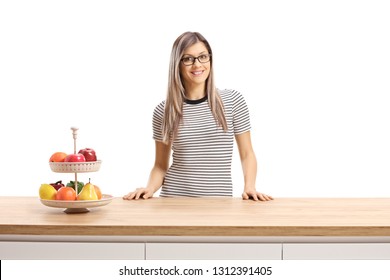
232, 91, 251, 134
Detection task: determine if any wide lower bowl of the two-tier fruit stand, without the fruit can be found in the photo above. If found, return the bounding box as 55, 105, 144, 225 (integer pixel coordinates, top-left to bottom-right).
40, 194, 114, 214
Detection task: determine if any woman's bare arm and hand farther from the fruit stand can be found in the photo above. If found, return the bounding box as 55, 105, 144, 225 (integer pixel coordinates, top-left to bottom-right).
235, 131, 273, 201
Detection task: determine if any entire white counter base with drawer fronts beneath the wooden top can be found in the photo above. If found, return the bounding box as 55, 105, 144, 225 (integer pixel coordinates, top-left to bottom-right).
0, 235, 390, 260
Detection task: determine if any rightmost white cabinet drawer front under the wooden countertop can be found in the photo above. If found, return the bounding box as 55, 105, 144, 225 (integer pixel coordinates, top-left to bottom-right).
283, 243, 390, 260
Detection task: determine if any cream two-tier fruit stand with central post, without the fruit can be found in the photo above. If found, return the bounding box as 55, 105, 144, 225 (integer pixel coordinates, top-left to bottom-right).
41, 127, 113, 214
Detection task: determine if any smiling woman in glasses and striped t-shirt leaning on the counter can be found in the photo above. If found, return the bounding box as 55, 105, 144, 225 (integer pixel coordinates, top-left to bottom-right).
123, 32, 273, 201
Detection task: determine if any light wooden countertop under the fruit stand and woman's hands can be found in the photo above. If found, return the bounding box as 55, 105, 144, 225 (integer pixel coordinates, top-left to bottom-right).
0, 197, 390, 236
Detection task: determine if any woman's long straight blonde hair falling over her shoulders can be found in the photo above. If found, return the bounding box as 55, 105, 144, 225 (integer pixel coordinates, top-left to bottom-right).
162, 32, 227, 143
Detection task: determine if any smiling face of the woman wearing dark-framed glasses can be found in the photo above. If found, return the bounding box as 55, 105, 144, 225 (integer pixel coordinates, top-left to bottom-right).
180, 42, 211, 88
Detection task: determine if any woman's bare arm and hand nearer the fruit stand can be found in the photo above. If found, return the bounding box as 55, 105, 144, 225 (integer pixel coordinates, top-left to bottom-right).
123, 141, 171, 200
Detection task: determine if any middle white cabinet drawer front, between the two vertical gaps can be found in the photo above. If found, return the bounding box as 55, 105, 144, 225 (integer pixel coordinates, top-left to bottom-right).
145, 243, 282, 260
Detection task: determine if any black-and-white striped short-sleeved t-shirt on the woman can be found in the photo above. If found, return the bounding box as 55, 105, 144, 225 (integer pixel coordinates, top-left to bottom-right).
153, 90, 250, 197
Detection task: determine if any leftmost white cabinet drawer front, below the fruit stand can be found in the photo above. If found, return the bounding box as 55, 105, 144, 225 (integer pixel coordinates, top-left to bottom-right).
0, 242, 145, 260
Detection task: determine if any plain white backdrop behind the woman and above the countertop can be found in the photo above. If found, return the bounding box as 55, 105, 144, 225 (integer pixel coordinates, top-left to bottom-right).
0, 0, 390, 197
